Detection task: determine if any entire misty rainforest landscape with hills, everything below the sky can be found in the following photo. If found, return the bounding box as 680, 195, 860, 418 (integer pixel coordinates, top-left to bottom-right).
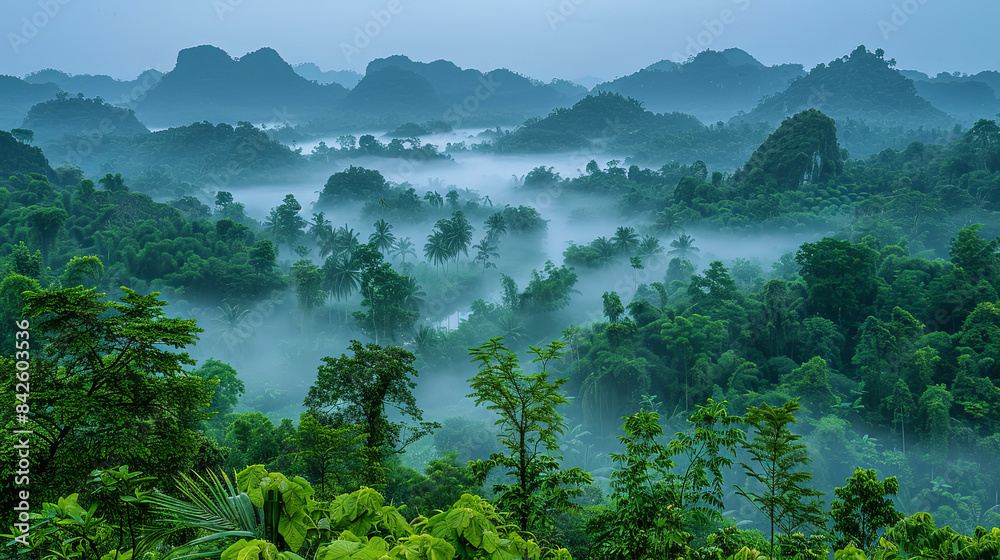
0, 46, 1000, 560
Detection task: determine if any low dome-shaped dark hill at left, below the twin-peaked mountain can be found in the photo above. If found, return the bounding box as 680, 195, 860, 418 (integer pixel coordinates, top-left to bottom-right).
21, 93, 149, 144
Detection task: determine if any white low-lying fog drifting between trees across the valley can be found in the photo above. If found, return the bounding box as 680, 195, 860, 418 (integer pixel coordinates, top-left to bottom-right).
199, 137, 831, 442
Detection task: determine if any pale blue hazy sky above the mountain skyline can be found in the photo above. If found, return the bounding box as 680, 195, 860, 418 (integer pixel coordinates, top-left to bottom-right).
0, 0, 1000, 81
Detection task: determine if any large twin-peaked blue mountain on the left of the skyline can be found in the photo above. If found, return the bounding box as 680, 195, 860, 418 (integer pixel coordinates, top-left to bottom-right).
136, 45, 347, 126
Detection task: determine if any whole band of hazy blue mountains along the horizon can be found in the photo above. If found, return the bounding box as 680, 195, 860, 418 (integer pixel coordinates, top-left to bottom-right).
0, 45, 1000, 134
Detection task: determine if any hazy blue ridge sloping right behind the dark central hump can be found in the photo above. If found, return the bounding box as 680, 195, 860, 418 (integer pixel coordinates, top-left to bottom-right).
365, 55, 578, 114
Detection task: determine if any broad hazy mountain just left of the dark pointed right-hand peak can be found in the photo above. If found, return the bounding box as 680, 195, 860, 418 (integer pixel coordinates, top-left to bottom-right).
594, 49, 804, 122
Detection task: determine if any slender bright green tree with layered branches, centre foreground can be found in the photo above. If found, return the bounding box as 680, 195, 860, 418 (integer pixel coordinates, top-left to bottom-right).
468, 337, 592, 540
